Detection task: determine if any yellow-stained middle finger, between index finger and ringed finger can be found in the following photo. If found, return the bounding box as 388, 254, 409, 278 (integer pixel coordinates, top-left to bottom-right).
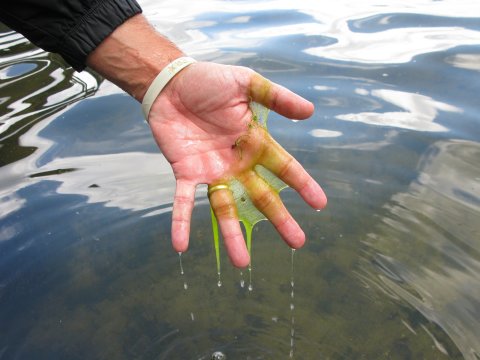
240, 170, 305, 249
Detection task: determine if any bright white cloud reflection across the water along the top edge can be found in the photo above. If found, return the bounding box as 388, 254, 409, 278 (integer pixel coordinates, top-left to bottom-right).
140, 0, 480, 64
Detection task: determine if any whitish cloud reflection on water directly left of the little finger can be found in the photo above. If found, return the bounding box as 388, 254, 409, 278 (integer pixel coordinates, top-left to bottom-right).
33, 152, 175, 213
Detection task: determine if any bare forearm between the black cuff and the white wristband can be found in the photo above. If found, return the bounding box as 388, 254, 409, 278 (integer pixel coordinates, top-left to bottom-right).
87, 15, 183, 102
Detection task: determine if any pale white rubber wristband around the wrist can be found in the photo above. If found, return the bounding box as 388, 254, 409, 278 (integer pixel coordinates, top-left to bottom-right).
142, 56, 196, 121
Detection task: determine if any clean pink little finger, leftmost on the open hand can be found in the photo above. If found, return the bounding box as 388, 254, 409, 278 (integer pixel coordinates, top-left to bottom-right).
172, 180, 195, 252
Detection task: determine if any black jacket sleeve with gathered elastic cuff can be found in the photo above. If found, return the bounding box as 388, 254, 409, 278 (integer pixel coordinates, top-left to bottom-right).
0, 0, 142, 71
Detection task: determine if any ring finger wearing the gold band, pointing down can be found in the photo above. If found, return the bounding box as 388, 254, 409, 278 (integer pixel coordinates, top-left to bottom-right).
209, 189, 250, 267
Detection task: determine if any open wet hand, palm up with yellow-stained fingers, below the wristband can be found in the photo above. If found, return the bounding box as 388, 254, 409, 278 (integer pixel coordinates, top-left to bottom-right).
149, 63, 327, 267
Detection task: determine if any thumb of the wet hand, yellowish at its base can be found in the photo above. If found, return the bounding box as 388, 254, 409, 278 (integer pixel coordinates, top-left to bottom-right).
249, 73, 314, 120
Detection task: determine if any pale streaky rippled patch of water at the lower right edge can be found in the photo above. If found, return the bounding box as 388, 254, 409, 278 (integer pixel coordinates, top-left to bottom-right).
364, 141, 480, 359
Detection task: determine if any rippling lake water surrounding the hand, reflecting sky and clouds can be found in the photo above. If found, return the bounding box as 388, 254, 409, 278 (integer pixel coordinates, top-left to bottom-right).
0, 0, 480, 360
